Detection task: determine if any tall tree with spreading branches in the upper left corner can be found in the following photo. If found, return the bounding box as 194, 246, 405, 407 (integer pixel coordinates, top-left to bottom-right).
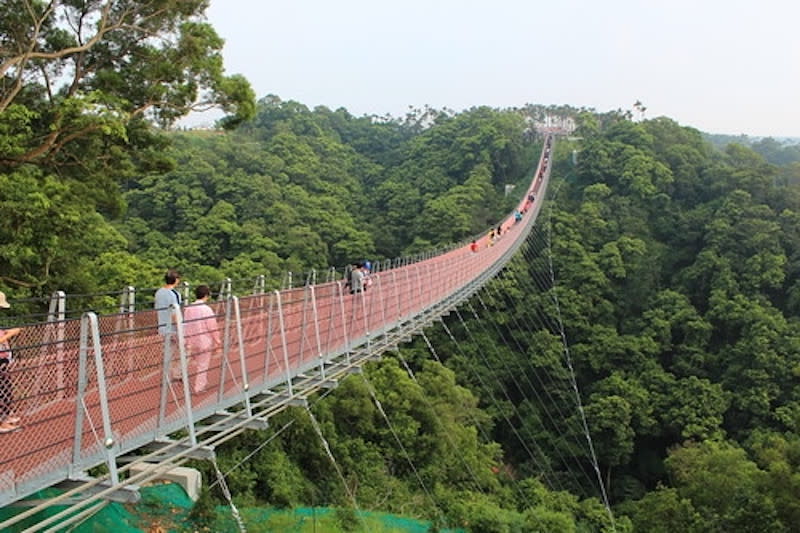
0, 0, 255, 292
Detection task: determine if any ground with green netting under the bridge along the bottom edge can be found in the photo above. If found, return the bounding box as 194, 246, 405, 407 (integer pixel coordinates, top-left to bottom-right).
0, 483, 461, 533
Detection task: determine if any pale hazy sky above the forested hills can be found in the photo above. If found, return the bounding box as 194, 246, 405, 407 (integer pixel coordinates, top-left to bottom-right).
195, 0, 800, 137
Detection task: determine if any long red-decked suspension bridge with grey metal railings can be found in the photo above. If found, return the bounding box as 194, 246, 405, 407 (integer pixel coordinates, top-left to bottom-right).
0, 135, 584, 531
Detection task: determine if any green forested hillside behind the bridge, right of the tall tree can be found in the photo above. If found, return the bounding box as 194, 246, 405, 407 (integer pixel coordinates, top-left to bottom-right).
117, 97, 536, 283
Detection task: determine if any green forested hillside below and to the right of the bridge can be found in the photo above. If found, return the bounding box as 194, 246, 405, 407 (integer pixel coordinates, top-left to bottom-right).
166, 108, 800, 531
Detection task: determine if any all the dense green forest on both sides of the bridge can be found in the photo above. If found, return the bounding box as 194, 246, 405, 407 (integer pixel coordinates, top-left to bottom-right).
0, 0, 800, 532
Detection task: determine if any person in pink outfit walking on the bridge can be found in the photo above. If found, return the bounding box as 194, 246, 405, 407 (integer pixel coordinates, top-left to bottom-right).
183, 285, 221, 393
